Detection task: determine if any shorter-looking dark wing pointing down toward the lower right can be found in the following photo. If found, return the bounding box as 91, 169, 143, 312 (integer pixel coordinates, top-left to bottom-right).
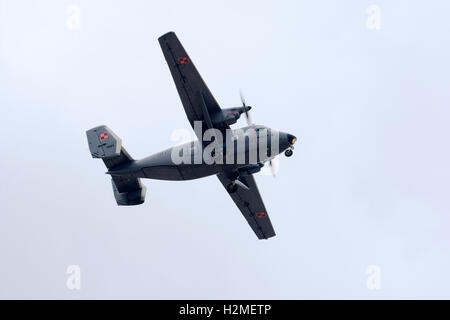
217, 173, 275, 239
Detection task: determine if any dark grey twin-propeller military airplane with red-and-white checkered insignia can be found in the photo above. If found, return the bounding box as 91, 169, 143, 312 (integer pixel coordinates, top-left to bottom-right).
86, 32, 297, 239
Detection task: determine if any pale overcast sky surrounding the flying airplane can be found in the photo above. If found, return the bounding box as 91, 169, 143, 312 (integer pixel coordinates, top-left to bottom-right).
0, 0, 450, 299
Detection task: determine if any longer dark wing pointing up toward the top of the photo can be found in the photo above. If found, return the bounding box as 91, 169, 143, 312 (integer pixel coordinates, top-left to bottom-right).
158, 32, 228, 140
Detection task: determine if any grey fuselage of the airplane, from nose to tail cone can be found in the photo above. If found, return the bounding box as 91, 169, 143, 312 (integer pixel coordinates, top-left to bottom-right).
107, 126, 295, 181
